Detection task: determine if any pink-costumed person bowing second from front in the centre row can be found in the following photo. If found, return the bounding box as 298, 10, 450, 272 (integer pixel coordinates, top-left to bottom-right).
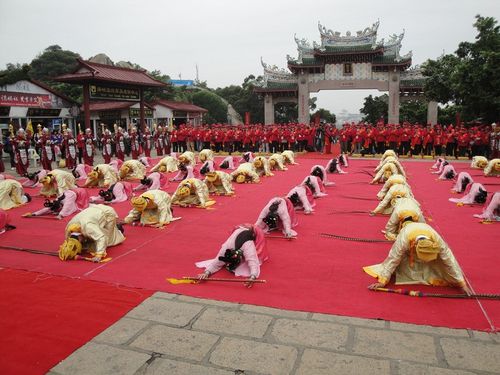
255, 197, 298, 238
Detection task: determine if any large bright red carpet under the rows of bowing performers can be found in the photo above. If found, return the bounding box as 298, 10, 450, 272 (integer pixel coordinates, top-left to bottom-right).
0, 155, 500, 330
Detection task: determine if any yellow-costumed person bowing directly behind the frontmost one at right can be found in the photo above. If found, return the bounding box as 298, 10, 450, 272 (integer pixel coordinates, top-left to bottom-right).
382, 197, 425, 241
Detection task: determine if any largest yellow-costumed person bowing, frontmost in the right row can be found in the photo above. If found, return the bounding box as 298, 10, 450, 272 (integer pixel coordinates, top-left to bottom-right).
363, 222, 470, 294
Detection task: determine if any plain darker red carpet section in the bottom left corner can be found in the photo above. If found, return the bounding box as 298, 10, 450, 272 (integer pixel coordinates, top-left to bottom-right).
0, 269, 152, 375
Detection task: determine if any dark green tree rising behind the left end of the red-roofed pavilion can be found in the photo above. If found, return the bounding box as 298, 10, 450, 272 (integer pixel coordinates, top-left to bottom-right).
29, 45, 82, 101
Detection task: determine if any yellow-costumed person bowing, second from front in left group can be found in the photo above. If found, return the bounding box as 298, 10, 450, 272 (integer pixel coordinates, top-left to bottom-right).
123, 190, 180, 228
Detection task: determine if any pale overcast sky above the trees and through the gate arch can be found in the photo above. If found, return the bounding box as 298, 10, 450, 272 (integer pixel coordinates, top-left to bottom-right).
0, 0, 500, 113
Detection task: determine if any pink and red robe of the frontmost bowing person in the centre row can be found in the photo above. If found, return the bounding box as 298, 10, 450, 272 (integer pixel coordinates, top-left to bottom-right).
196, 226, 268, 277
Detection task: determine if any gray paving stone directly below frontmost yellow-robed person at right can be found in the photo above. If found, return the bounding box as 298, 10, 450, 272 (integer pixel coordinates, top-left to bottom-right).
353, 328, 437, 364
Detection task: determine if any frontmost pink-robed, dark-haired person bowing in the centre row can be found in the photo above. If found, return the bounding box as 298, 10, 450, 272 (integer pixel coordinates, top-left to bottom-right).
196, 224, 267, 287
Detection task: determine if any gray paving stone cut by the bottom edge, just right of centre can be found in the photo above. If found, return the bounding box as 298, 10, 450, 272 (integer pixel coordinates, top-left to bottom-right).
296, 349, 391, 375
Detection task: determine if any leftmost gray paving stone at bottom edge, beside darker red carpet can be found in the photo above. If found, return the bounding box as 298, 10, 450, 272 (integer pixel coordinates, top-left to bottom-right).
53, 342, 150, 375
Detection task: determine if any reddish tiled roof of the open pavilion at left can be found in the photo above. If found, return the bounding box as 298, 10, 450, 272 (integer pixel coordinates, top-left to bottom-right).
54, 59, 167, 87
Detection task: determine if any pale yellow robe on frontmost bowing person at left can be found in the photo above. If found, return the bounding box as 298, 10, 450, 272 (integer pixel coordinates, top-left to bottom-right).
66, 204, 125, 258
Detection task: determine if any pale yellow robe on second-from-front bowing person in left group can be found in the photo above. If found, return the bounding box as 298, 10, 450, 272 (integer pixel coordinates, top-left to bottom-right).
123, 190, 173, 225
